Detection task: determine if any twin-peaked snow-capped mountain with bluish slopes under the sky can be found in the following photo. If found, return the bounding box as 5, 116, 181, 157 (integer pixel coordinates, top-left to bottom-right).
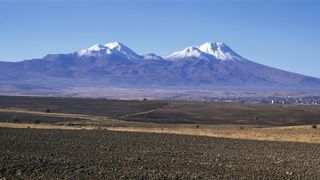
0, 42, 320, 89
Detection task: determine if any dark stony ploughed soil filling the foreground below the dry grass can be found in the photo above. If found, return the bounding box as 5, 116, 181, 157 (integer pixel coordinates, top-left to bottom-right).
0, 128, 320, 179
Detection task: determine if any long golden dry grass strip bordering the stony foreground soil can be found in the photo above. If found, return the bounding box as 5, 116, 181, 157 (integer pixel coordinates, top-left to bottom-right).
0, 123, 320, 144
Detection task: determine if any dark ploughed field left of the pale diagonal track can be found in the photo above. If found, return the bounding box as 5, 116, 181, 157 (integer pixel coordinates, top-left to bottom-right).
0, 96, 167, 117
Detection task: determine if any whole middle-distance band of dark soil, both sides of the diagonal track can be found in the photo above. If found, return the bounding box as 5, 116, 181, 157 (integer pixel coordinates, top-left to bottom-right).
0, 96, 320, 126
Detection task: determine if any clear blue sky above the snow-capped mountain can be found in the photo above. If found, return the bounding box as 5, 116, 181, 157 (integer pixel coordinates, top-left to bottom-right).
0, 0, 320, 77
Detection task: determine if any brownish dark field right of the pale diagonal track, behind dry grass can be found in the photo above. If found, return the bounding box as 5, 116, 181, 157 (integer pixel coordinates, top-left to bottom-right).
128, 102, 320, 126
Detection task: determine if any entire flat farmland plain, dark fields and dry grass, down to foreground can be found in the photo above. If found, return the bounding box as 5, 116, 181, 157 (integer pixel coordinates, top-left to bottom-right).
0, 96, 320, 179
